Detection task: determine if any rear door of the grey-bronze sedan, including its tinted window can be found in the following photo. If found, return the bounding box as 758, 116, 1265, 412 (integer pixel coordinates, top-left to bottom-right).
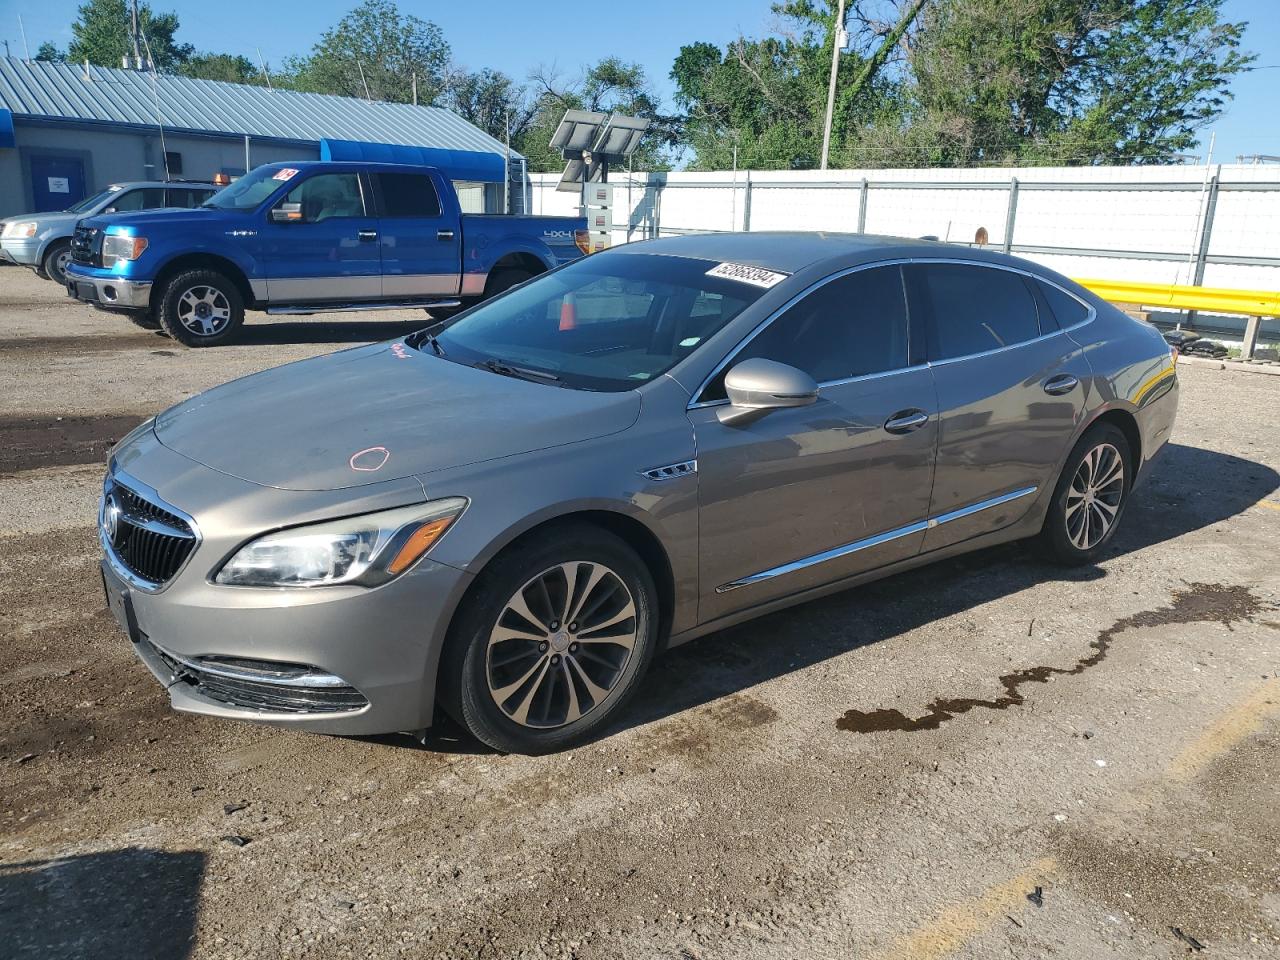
906, 261, 1091, 550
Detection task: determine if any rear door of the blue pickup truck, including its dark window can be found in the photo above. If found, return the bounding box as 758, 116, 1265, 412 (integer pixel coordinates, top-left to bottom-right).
370, 170, 462, 300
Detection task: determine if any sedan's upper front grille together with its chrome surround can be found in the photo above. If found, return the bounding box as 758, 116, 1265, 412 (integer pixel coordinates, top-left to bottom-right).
97, 466, 201, 593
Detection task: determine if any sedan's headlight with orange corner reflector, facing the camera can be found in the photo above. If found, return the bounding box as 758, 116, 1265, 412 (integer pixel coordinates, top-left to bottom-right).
214, 497, 467, 586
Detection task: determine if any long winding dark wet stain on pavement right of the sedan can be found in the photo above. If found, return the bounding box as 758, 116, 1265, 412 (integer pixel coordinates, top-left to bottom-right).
836, 584, 1263, 733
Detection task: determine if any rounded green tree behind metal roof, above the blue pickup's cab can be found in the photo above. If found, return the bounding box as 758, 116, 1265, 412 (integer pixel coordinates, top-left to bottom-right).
284, 0, 449, 104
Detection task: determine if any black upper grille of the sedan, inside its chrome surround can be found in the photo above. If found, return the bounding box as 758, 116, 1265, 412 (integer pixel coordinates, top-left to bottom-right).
101, 479, 196, 588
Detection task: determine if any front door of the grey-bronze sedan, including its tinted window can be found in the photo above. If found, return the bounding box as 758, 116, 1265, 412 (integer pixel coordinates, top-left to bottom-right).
689, 265, 937, 622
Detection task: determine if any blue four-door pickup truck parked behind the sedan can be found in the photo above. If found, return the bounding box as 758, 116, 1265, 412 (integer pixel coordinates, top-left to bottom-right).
67, 161, 589, 347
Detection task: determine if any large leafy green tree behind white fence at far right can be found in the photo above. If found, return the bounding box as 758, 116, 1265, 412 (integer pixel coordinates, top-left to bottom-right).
900, 0, 1253, 164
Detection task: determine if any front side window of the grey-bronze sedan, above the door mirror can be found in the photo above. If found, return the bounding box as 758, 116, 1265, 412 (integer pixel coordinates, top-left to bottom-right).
699, 266, 909, 402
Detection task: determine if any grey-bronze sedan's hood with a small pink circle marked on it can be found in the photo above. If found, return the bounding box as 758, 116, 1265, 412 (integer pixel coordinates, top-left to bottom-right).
155, 343, 640, 490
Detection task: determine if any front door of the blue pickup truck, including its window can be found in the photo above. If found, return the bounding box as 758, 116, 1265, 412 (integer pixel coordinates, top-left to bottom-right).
261, 169, 383, 303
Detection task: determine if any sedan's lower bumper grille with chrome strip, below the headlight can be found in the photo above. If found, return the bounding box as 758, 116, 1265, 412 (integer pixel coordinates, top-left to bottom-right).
142, 639, 369, 714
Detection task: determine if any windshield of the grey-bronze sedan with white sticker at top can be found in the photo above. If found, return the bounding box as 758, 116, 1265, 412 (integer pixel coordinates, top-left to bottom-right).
430, 255, 764, 390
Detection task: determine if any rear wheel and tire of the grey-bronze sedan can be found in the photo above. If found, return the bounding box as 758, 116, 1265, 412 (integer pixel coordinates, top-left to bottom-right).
1037, 424, 1134, 566
